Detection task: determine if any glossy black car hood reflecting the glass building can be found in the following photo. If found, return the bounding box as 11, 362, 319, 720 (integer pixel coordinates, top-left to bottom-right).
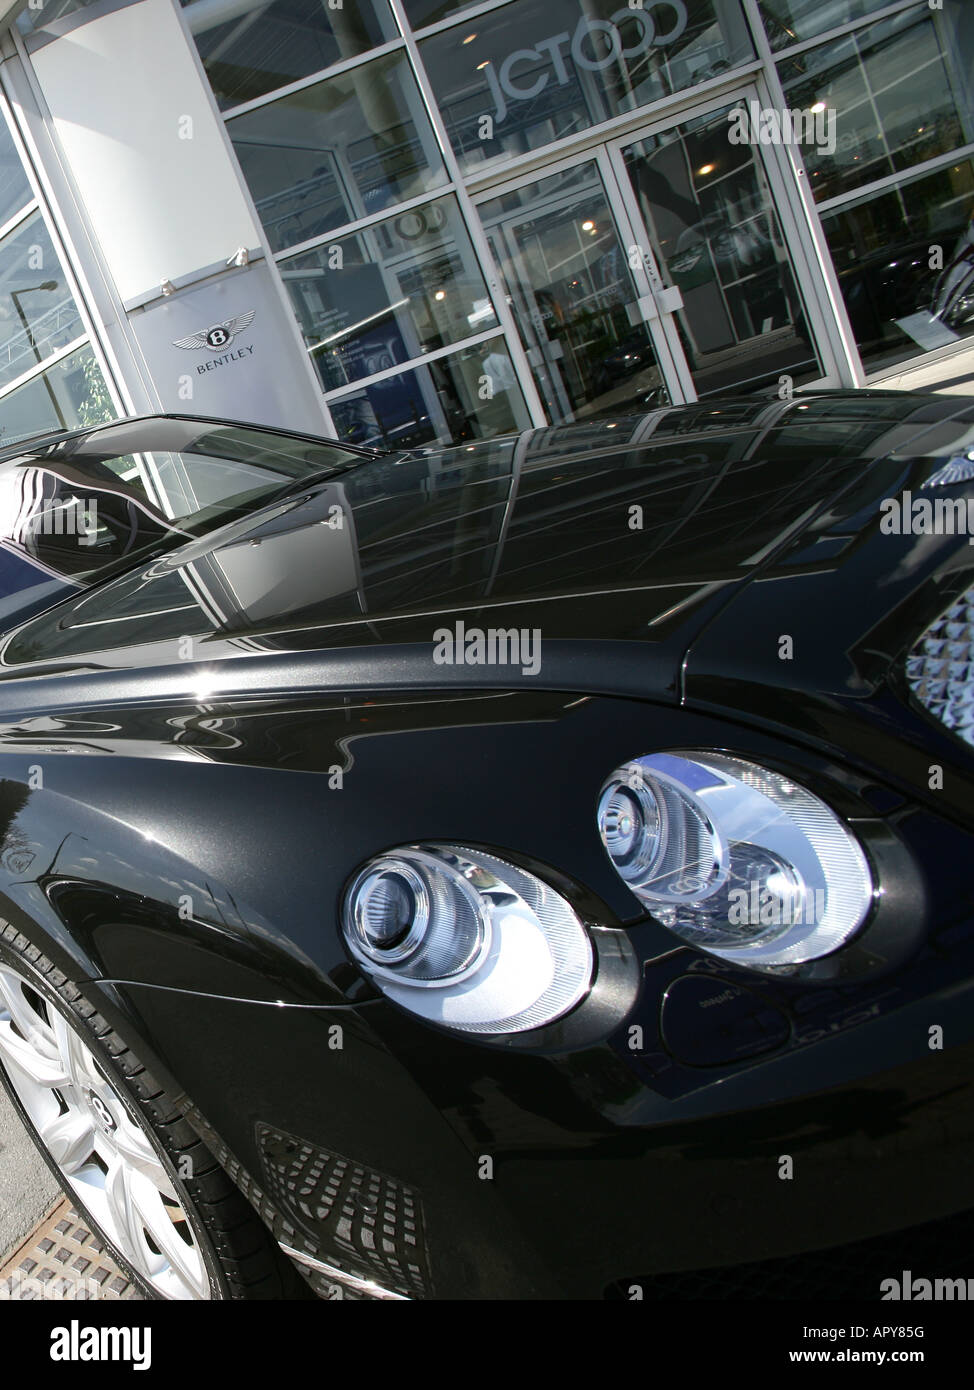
0, 392, 970, 699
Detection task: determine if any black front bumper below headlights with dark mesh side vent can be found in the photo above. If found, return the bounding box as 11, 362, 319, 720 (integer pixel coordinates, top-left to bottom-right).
104, 952, 974, 1298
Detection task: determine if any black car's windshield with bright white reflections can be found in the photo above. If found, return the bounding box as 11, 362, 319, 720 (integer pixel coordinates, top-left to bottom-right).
0, 418, 361, 594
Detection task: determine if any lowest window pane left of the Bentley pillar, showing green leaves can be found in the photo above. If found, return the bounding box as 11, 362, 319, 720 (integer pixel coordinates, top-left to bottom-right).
0, 348, 117, 448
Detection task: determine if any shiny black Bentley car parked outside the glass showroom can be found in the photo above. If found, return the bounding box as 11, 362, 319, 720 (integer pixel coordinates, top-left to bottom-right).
0, 392, 974, 1300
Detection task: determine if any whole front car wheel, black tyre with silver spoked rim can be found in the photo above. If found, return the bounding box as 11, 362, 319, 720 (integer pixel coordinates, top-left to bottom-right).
0, 920, 295, 1300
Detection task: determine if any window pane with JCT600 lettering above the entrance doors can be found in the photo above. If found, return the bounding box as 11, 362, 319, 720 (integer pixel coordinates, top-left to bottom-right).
421, 0, 753, 172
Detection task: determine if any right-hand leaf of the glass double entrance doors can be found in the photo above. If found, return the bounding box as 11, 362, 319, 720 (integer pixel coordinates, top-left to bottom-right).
610, 90, 825, 399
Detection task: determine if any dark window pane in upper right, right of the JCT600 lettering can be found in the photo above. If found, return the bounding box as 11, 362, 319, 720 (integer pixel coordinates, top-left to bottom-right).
779, 8, 974, 200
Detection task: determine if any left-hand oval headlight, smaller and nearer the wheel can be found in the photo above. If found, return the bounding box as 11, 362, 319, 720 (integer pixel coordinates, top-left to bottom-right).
342, 845, 593, 1034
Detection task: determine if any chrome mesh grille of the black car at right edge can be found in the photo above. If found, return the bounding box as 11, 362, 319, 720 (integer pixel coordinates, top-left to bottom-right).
906, 585, 974, 748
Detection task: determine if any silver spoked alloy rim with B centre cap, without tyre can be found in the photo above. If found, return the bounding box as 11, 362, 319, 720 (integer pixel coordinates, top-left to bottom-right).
0, 963, 210, 1300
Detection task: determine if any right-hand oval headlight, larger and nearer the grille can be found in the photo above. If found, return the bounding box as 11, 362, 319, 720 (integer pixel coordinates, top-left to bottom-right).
599, 751, 874, 966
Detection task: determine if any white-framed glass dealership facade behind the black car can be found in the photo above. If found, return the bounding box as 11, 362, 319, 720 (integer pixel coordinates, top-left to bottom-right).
0, 0, 974, 448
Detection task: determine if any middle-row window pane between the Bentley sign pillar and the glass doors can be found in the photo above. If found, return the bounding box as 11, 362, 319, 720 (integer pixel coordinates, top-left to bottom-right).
281, 197, 497, 391
